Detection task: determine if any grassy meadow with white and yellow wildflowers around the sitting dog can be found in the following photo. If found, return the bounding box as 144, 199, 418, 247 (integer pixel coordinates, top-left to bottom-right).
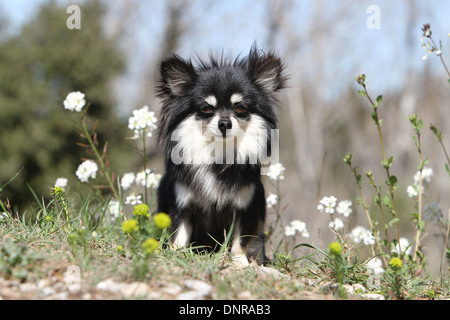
0, 17, 450, 300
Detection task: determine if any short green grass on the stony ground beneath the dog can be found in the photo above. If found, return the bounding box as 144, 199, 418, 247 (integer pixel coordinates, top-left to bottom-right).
0, 200, 450, 300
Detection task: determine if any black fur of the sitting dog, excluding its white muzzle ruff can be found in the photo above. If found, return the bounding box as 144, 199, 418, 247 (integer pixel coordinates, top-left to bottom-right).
157, 46, 286, 263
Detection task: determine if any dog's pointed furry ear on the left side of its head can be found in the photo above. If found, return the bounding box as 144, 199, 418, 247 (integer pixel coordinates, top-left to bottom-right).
159, 54, 197, 96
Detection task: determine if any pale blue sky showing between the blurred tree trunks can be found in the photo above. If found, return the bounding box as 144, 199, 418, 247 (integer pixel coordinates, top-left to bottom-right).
0, 0, 450, 109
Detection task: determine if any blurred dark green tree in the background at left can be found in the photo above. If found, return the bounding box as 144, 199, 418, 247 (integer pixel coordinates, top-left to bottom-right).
0, 1, 131, 212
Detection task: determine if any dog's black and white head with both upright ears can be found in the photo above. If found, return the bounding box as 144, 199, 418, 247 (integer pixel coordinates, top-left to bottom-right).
159, 47, 286, 166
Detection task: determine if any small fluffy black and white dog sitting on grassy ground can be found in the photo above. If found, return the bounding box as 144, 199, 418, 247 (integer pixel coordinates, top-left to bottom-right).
157, 44, 287, 267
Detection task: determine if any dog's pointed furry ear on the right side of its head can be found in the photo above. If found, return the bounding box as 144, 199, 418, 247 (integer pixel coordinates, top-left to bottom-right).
246, 44, 287, 93
